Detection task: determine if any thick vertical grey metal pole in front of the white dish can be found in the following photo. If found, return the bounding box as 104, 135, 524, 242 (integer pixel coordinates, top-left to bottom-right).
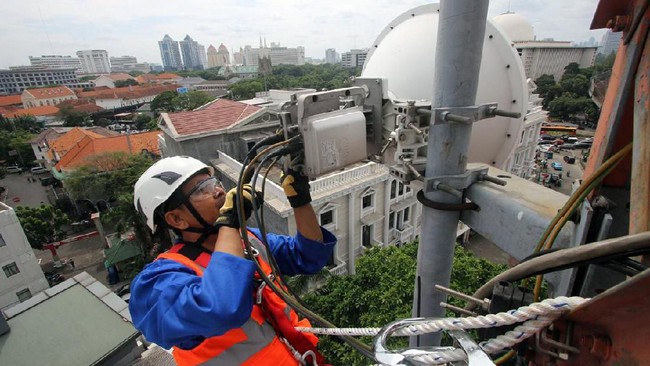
410, 0, 488, 347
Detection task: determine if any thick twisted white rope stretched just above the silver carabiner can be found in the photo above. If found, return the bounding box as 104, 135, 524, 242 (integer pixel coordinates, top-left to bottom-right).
296, 296, 588, 336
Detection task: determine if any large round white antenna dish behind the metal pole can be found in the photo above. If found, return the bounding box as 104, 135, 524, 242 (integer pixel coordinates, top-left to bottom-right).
361, 4, 528, 170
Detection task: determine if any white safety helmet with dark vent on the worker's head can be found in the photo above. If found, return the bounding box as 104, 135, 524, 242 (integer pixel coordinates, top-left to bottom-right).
133, 156, 214, 232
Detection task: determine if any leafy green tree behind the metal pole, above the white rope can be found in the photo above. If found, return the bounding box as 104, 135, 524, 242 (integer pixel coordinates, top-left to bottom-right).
304, 243, 506, 365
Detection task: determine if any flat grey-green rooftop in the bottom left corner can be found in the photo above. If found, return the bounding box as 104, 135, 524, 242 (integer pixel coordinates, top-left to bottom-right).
0, 272, 139, 366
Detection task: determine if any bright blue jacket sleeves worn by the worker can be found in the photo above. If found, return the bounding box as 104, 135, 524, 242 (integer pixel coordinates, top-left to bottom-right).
129, 229, 336, 349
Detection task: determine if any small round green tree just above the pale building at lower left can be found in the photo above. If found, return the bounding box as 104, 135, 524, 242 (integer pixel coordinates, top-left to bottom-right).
16, 205, 70, 250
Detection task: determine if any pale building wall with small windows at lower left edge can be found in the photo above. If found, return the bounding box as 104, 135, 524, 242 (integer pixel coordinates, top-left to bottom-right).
0, 202, 50, 310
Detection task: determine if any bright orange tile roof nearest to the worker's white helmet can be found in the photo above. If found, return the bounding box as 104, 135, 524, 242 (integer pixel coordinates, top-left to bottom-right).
55, 131, 161, 170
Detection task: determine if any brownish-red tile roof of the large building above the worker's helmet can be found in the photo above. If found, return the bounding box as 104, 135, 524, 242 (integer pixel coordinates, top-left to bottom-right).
163, 99, 262, 136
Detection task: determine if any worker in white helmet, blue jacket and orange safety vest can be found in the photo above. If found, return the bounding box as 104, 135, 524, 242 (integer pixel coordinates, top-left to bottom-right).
129, 156, 336, 366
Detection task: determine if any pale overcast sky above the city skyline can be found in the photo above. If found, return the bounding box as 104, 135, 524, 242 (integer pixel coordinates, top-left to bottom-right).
0, 0, 604, 69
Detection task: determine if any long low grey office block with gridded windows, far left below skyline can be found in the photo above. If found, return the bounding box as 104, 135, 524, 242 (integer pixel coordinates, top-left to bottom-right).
0, 67, 82, 94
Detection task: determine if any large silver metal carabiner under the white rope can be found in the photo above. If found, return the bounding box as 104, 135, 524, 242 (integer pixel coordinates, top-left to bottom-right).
373, 318, 494, 366
